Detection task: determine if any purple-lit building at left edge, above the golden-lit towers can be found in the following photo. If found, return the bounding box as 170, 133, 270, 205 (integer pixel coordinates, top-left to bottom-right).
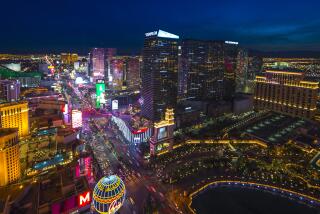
0, 80, 20, 102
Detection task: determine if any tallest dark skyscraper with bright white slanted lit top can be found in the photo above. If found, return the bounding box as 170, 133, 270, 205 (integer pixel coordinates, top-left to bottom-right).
141, 30, 179, 121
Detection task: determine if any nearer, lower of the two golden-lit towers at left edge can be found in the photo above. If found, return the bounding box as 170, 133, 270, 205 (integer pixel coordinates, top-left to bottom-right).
0, 128, 21, 186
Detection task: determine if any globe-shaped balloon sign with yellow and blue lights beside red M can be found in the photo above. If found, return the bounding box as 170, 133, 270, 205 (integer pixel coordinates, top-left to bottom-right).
93, 175, 126, 214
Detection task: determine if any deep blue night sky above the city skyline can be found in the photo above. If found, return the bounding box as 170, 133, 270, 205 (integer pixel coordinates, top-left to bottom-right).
0, 0, 320, 53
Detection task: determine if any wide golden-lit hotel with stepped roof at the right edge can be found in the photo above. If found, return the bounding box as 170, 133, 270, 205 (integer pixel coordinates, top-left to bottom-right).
254, 70, 319, 118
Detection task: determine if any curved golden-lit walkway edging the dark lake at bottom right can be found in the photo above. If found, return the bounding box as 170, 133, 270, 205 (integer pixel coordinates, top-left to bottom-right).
188, 180, 320, 214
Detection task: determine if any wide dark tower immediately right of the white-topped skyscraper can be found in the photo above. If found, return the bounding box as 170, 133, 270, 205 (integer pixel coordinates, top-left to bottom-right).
179, 40, 224, 100
